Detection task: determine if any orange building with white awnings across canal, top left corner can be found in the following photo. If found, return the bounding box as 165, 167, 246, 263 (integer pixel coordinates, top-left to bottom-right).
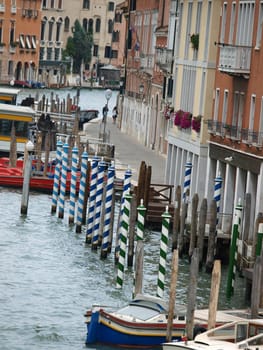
0, 0, 41, 85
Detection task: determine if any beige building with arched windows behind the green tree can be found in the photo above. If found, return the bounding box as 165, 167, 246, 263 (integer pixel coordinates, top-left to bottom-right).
40, 0, 124, 86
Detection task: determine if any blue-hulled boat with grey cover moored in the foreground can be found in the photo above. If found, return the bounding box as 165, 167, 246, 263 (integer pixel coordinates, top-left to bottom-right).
85, 294, 250, 348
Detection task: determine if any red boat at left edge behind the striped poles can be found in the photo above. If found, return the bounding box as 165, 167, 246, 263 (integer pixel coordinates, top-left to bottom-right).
0, 158, 79, 193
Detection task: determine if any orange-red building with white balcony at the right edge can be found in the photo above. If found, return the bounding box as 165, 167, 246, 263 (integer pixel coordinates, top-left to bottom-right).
206, 0, 263, 239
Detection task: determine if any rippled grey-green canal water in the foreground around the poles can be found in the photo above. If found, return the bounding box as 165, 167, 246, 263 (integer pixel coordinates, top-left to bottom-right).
0, 187, 249, 350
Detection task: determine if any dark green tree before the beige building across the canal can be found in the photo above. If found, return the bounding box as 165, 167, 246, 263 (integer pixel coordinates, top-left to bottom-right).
63, 20, 93, 75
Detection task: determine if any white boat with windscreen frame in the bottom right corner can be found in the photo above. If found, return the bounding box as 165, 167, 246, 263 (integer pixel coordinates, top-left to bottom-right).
162, 318, 263, 350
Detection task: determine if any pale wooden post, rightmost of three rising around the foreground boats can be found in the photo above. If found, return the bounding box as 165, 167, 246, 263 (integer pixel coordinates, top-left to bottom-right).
207, 260, 221, 329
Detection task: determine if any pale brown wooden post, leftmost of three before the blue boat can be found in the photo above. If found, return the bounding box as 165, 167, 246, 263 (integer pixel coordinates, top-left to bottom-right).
166, 249, 178, 342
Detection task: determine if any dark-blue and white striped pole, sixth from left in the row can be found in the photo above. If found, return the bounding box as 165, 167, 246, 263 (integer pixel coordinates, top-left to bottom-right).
91, 160, 106, 250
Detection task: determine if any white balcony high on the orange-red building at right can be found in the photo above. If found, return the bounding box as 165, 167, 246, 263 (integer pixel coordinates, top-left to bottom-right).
218, 44, 252, 77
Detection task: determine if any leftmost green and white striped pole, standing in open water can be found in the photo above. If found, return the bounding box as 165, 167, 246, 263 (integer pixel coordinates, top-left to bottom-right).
116, 194, 132, 289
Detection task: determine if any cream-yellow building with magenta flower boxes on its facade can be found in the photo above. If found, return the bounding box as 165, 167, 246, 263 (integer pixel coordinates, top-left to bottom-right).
166, 0, 221, 198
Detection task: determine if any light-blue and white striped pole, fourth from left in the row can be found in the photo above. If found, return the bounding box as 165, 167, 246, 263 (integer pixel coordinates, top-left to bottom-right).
76, 151, 88, 233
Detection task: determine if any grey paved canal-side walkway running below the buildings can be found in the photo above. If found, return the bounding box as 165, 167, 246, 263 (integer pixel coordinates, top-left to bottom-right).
86, 117, 166, 184
